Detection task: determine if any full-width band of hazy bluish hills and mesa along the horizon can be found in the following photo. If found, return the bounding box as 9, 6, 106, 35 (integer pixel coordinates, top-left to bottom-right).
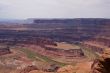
0, 18, 110, 25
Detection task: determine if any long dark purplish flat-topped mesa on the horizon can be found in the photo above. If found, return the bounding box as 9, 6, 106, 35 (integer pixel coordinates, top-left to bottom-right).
34, 18, 110, 24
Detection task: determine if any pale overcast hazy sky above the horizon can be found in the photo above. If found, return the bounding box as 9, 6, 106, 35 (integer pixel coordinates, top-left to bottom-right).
0, 0, 110, 19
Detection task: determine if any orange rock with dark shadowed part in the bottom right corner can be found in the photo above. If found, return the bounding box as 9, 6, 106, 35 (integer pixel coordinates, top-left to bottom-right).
91, 49, 110, 73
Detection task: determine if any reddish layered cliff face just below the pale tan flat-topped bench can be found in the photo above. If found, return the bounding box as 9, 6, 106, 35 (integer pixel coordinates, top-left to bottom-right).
45, 47, 84, 59
